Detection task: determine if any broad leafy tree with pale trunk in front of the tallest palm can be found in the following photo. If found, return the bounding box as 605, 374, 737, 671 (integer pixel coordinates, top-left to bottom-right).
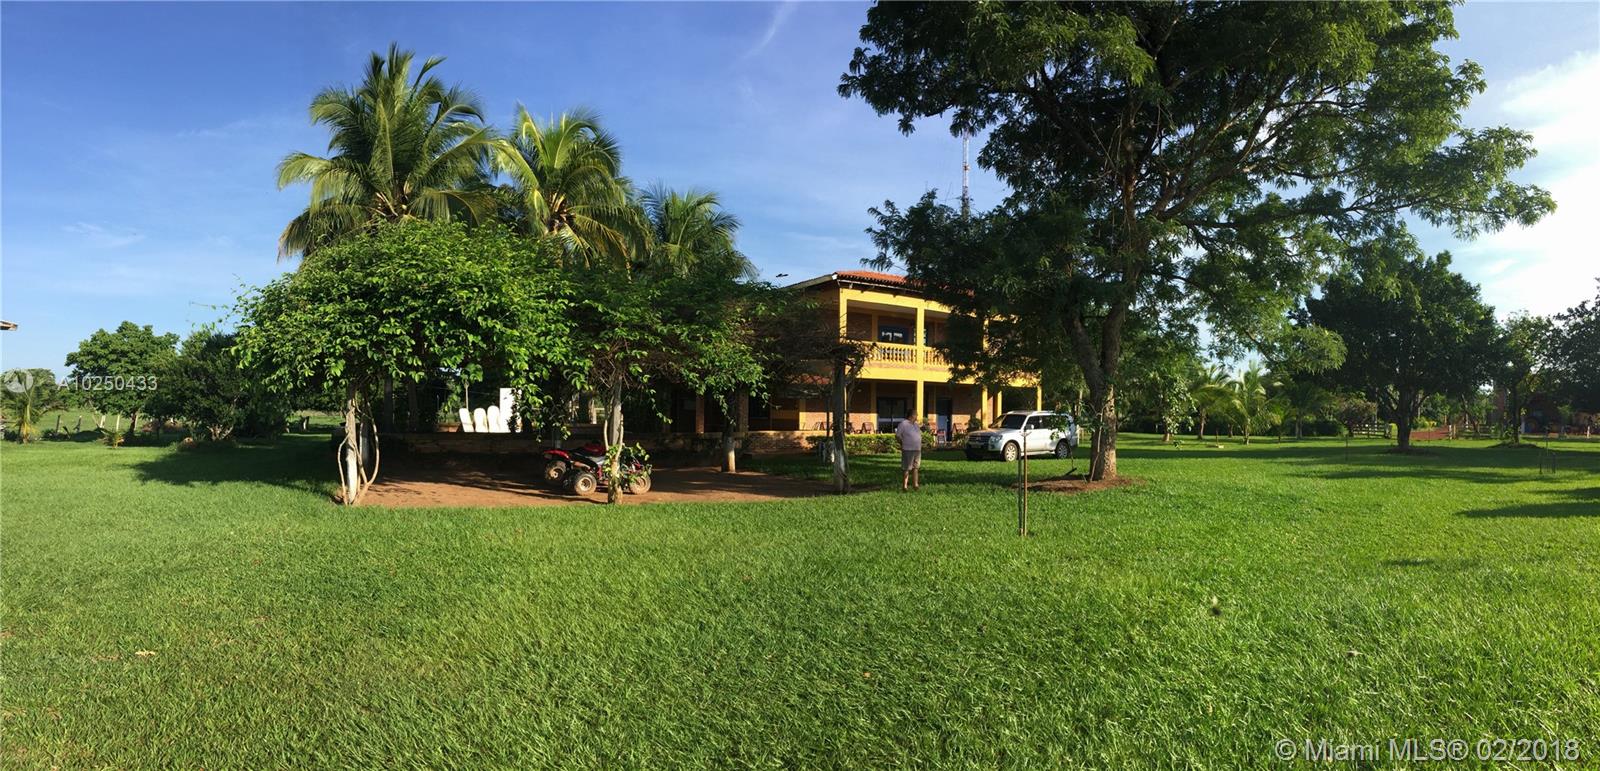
237, 221, 578, 504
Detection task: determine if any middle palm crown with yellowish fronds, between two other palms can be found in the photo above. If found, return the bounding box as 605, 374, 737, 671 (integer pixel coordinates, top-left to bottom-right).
494, 109, 645, 266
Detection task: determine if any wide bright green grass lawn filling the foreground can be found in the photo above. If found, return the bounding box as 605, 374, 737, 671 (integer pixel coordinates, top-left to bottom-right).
0, 435, 1600, 768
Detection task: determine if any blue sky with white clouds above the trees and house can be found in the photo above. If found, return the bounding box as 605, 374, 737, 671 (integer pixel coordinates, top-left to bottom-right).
0, 2, 1600, 370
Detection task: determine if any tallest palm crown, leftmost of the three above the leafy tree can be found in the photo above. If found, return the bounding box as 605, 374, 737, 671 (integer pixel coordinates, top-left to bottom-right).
278, 45, 494, 259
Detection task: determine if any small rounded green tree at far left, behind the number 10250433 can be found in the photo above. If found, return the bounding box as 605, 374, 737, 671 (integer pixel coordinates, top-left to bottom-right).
67, 322, 178, 430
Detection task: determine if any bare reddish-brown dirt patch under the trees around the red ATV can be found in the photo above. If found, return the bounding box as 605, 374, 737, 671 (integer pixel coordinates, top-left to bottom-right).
362, 454, 829, 507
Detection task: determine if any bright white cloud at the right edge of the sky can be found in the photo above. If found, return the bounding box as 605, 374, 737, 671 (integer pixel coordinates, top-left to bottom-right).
1456, 51, 1600, 314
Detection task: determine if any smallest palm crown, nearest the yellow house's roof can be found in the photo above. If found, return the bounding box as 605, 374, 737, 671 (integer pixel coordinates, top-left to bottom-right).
640, 186, 757, 278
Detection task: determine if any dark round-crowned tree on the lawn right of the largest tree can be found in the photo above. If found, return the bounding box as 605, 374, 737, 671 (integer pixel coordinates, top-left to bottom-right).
1306, 232, 1499, 451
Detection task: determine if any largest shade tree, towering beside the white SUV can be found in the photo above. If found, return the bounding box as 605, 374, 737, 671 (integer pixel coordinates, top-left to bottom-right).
840, 2, 1552, 477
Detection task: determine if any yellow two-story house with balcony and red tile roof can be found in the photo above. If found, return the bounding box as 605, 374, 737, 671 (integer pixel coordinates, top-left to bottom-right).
662, 270, 1040, 451
